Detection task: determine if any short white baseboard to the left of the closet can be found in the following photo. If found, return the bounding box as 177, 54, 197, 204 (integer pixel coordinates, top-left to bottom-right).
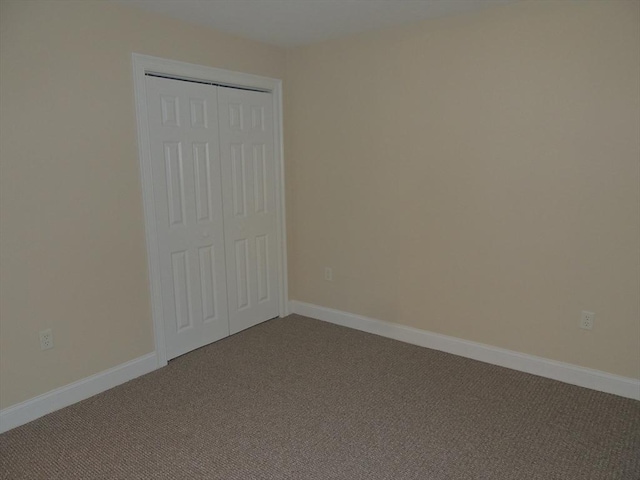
0, 352, 159, 433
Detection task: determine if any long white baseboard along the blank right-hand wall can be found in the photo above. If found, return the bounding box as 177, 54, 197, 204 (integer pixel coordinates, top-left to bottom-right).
289, 300, 640, 400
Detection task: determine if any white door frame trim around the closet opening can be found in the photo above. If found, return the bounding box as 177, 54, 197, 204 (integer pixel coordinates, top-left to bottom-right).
131, 53, 289, 367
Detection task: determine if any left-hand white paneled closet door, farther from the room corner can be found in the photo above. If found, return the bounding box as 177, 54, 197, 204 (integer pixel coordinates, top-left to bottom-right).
146, 77, 229, 359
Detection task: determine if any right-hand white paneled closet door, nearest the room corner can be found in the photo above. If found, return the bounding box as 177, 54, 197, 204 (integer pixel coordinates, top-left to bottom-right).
218, 87, 279, 333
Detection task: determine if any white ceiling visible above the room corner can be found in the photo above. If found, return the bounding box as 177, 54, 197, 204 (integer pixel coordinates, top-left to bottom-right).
116, 0, 514, 47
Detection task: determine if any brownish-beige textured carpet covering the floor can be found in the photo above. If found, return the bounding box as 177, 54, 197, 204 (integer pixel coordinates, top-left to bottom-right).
0, 316, 640, 480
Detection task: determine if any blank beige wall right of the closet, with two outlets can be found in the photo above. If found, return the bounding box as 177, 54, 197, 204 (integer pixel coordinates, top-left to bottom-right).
285, 1, 640, 378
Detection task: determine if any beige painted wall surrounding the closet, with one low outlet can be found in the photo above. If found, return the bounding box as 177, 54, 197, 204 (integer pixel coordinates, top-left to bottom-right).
0, 0, 285, 408
